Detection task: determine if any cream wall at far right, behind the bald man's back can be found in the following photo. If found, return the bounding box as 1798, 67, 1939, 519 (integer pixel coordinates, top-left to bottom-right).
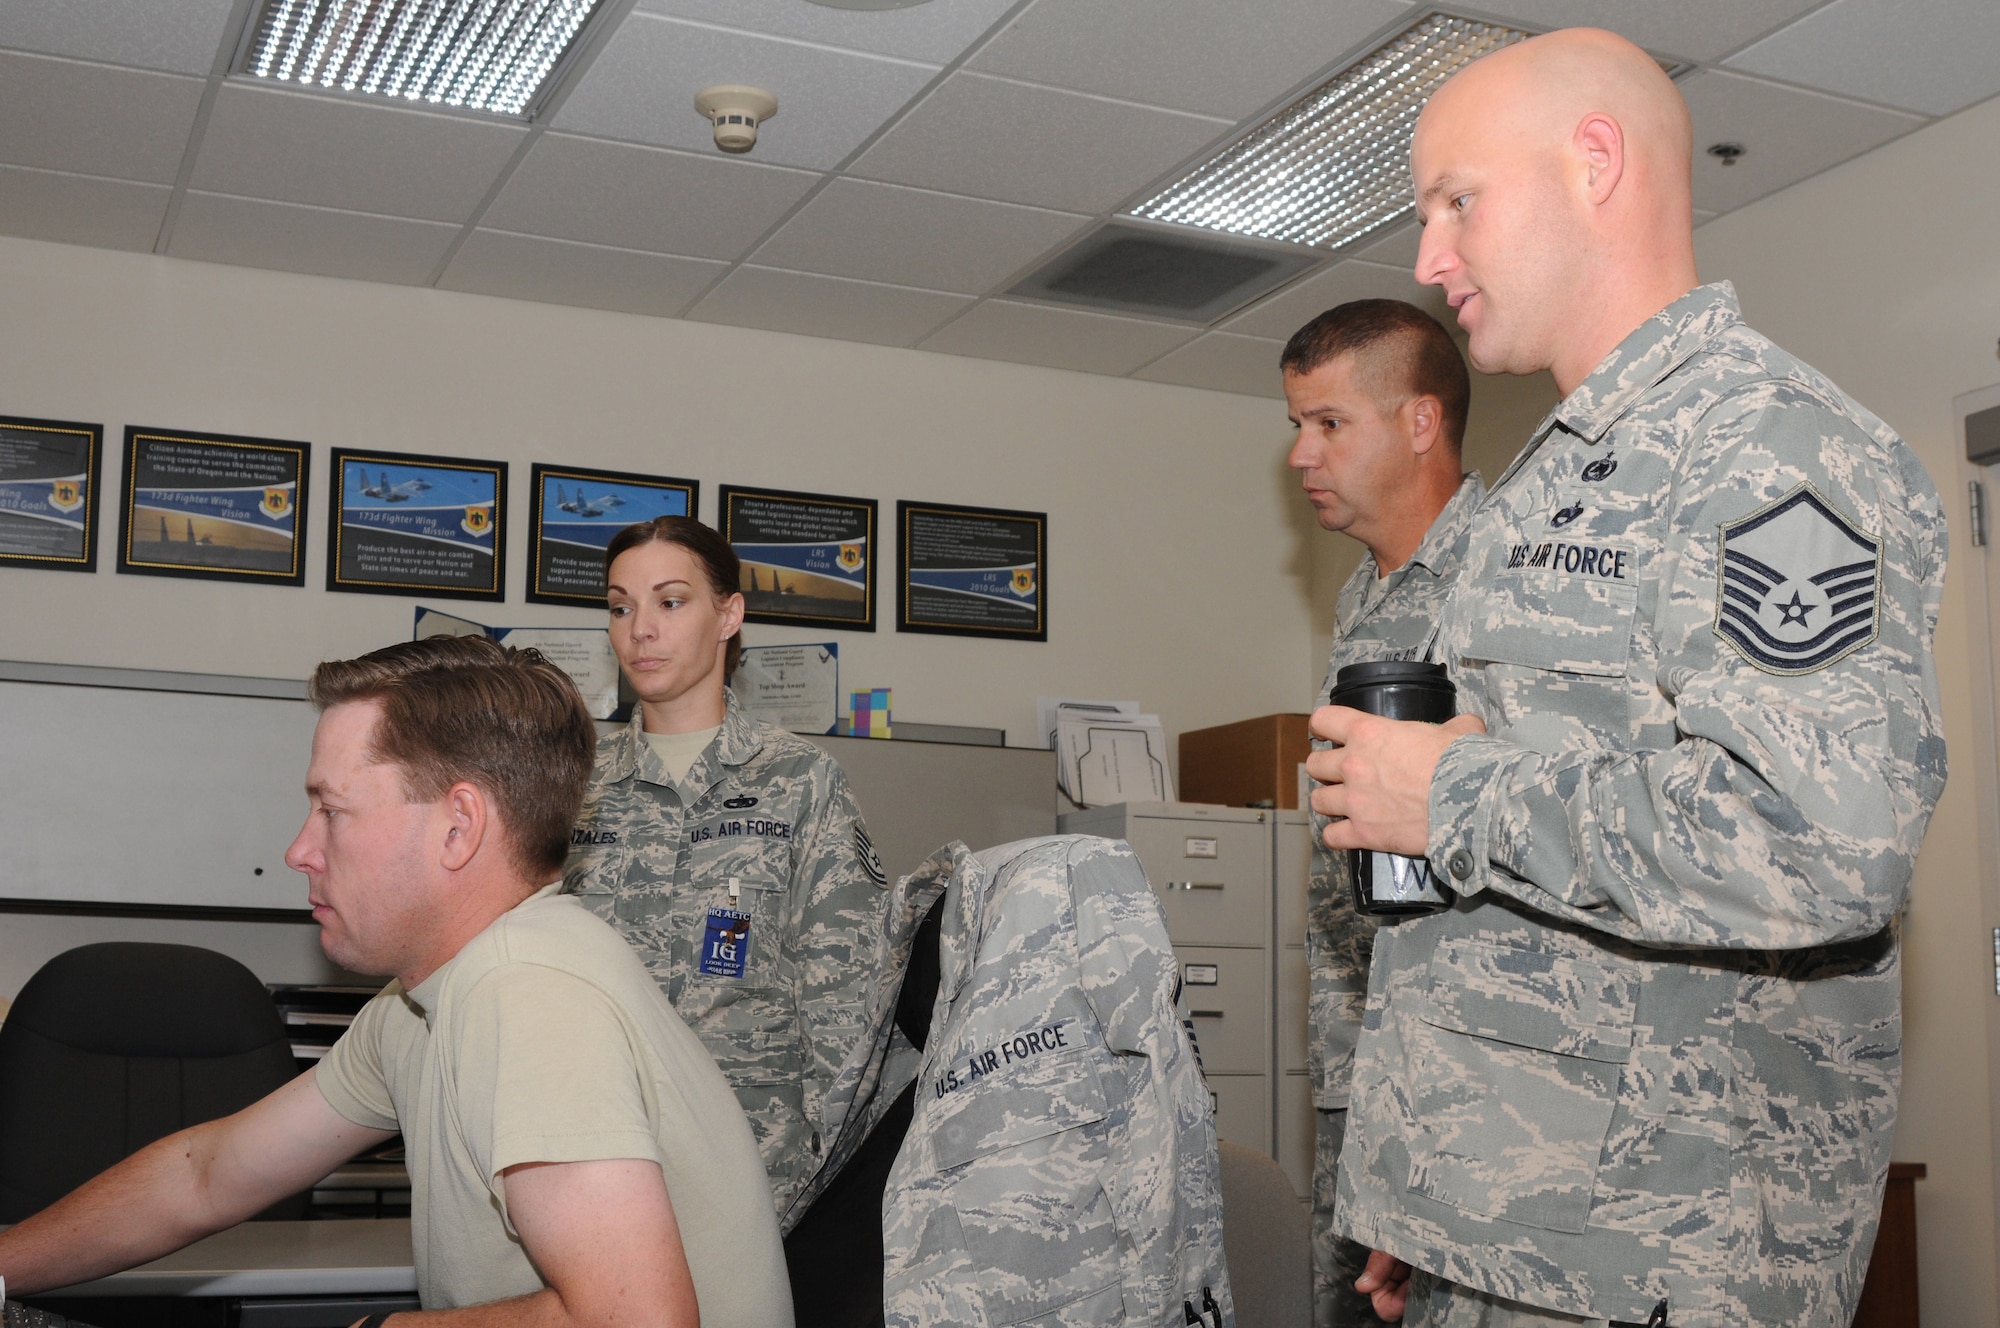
1696, 100, 2000, 1328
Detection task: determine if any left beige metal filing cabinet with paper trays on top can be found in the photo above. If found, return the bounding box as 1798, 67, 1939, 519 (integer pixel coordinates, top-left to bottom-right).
1058, 802, 1278, 1154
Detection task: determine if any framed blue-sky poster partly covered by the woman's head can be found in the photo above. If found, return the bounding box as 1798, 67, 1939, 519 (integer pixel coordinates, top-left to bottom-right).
528, 462, 702, 608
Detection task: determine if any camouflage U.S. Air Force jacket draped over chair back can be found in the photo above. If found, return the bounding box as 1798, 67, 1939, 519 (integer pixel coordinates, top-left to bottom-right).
880, 836, 1234, 1328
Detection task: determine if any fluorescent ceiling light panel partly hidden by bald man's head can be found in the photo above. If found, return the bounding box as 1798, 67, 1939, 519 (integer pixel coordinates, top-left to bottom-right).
1132, 14, 1528, 250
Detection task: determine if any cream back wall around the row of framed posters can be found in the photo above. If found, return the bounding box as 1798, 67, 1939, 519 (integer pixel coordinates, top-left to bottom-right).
0, 240, 1310, 742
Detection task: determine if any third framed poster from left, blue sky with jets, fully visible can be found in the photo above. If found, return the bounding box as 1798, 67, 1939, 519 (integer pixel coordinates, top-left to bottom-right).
326, 448, 506, 600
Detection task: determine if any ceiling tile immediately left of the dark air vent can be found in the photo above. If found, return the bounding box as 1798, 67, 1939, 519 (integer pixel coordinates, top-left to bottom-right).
754, 180, 1090, 294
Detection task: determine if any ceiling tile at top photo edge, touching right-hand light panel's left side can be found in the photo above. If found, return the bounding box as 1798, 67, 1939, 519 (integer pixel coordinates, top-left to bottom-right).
968, 0, 1412, 120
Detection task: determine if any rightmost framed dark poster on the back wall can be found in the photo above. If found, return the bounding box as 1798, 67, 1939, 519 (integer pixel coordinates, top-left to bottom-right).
896, 502, 1048, 640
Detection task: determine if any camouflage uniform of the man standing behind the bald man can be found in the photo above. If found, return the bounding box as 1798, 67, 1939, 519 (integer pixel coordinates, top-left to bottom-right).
1306, 474, 1486, 1328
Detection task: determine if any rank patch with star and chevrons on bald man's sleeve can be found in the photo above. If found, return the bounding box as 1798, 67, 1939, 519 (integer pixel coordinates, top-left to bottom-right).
1716, 484, 1882, 674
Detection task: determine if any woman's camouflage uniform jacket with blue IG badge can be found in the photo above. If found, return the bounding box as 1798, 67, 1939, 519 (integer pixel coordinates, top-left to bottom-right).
564, 694, 886, 1214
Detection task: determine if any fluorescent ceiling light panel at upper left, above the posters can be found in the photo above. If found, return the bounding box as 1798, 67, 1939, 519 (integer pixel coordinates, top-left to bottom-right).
242, 0, 598, 116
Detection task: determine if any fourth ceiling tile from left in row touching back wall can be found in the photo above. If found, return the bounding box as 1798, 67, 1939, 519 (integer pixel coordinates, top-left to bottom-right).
688, 266, 972, 346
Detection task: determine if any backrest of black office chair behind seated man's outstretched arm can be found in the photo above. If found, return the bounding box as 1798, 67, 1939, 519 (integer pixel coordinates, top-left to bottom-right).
0, 942, 310, 1222
